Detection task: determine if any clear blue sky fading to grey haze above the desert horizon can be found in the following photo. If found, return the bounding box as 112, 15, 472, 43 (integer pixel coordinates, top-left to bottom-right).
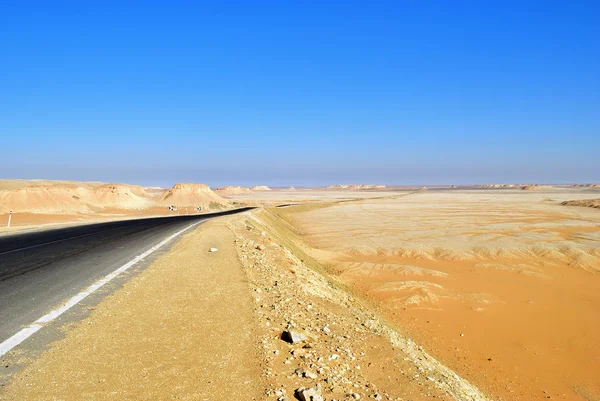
0, 1, 600, 186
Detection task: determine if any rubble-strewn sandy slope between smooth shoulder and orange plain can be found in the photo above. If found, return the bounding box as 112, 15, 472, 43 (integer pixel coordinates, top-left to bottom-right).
239, 211, 488, 401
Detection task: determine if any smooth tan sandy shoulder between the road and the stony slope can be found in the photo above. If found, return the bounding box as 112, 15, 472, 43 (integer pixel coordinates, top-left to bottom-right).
0, 219, 264, 400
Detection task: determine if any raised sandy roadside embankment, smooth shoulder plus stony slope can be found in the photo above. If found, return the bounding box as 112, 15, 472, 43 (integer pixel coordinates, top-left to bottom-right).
0, 212, 487, 401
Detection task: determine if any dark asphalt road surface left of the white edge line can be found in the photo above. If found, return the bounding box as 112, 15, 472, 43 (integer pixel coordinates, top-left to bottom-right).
0, 208, 249, 343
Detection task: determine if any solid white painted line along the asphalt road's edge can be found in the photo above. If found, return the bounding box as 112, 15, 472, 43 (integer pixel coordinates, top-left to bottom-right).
0, 220, 203, 357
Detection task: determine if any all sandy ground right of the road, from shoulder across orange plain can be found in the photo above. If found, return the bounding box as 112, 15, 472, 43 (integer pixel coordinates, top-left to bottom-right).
0, 191, 600, 401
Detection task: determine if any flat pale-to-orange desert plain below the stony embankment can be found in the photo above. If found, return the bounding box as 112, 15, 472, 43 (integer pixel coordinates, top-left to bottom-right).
274, 189, 600, 400
